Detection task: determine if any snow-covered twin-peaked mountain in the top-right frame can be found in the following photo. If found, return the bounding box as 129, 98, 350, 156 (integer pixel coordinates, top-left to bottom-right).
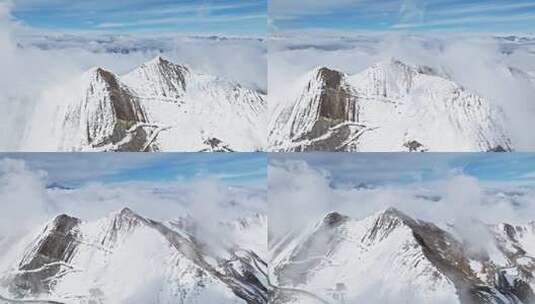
268, 59, 513, 151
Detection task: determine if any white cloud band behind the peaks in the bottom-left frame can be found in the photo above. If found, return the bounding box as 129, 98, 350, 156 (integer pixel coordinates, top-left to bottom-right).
0, 156, 267, 255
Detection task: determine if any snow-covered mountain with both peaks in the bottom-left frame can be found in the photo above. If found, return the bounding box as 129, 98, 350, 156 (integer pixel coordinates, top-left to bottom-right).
0, 208, 268, 304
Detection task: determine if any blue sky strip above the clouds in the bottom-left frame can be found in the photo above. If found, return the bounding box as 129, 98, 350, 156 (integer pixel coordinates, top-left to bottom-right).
0, 153, 267, 188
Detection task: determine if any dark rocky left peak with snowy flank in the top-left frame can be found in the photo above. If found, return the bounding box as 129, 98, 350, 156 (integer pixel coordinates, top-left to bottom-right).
62, 68, 155, 151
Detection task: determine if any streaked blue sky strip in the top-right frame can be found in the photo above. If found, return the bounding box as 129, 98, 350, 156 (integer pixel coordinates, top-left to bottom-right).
269, 0, 535, 33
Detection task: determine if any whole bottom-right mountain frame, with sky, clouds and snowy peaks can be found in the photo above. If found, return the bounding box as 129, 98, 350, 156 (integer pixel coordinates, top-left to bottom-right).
268, 153, 535, 304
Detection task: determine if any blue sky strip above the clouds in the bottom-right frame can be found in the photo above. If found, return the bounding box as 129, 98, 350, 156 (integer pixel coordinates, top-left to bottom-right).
269, 153, 535, 186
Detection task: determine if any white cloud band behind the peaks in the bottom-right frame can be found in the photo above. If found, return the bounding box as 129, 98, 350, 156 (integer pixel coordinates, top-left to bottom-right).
268, 157, 535, 238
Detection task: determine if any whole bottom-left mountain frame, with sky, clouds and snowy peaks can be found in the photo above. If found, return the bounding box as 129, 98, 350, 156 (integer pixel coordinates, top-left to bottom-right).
0, 153, 268, 304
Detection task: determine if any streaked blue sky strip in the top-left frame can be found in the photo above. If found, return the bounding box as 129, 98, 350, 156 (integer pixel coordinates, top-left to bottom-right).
9, 0, 267, 35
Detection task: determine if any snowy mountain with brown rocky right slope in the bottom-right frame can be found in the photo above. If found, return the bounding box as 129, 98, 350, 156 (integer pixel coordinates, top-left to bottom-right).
269, 209, 535, 304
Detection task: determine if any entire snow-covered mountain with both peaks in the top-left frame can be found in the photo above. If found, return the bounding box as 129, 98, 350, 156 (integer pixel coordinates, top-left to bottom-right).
21, 57, 267, 152
